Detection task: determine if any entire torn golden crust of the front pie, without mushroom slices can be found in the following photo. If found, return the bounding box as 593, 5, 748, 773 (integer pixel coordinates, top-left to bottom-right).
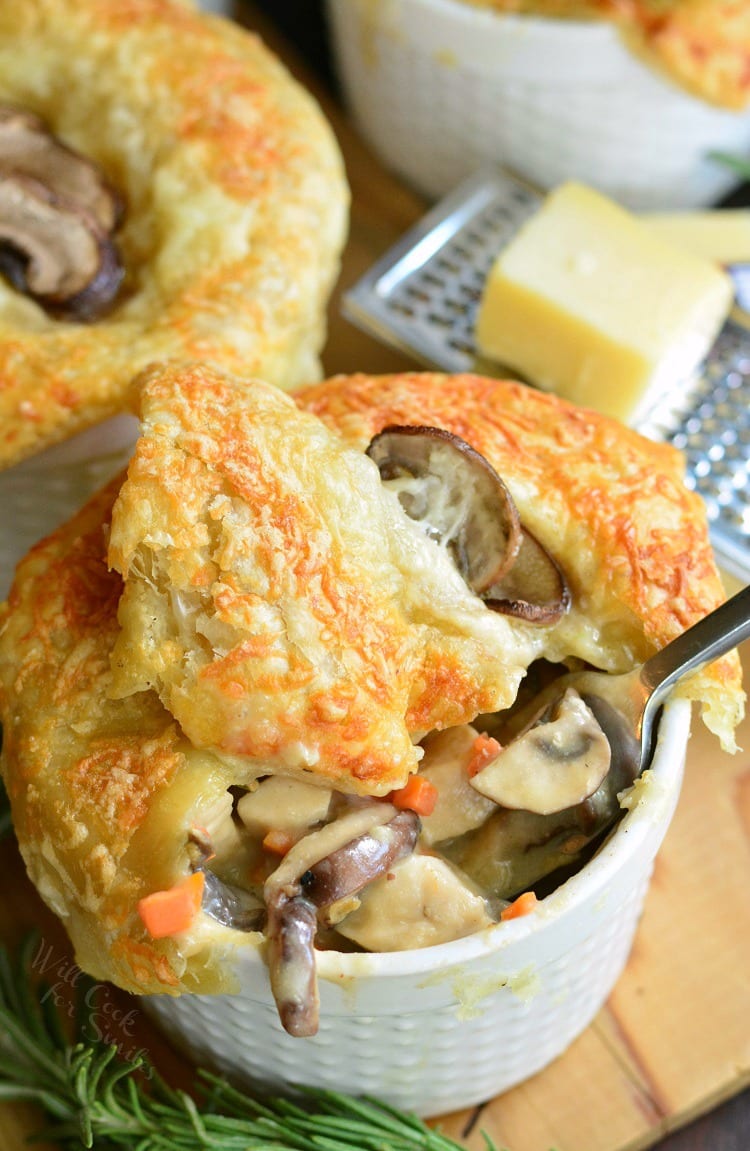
0, 365, 743, 993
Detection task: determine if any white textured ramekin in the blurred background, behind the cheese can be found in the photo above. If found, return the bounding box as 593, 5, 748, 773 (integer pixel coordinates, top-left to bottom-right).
328, 0, 750, 208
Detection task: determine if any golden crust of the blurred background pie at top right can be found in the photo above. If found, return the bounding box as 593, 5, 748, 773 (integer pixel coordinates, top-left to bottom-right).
462, 0, 750, 112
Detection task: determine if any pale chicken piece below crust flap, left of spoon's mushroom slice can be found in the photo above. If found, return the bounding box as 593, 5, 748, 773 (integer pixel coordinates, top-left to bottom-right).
420, 724, 497, 846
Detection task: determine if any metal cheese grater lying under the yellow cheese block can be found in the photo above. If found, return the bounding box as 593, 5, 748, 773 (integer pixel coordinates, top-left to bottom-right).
344, 170, 750, 581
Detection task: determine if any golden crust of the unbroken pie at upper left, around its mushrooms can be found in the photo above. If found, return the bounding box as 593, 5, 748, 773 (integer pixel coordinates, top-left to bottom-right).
0, 0, 347, 467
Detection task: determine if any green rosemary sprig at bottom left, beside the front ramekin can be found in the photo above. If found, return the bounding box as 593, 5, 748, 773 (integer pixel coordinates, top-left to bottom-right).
0, 938, 498, 1151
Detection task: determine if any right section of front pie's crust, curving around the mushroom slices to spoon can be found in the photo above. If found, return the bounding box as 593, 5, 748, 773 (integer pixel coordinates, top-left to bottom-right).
296, 373, 744, 749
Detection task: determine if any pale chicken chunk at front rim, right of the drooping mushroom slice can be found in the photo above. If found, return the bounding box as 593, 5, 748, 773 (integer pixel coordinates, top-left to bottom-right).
337, 855, 493, 951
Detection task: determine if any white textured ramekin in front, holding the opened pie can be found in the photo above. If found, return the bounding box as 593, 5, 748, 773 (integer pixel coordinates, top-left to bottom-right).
143, 700, 690, 1115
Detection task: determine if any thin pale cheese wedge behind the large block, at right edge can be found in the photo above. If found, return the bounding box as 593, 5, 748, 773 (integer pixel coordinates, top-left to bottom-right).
638, 208, 750, 264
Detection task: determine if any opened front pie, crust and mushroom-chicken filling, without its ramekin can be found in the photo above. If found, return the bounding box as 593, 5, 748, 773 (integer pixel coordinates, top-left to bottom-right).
0, 364, 743, 1035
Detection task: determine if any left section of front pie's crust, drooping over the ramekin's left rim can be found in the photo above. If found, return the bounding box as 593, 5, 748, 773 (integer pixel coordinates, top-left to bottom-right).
0, 477, 247, 991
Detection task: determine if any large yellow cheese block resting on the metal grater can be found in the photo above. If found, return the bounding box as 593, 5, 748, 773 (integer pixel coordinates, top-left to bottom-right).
475, 183, 733, 422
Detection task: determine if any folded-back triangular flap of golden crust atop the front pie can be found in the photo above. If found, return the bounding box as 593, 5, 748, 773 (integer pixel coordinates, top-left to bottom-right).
109, 365, 545, 794
